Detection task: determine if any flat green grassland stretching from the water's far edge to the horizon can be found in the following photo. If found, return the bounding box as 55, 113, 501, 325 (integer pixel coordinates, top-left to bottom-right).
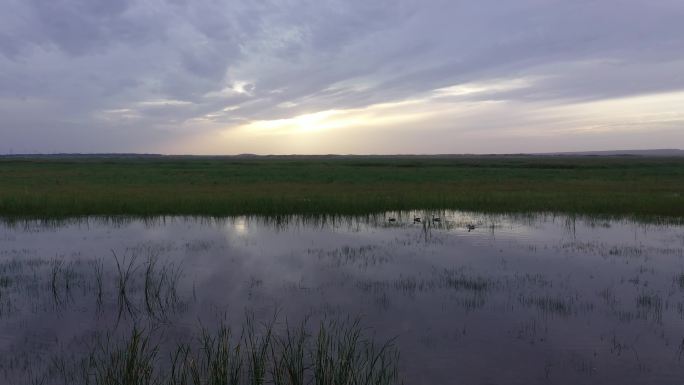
0, 156, 684, 218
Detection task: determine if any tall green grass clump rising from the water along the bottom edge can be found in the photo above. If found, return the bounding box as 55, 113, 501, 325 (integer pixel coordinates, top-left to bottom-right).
50, 316, 400, 385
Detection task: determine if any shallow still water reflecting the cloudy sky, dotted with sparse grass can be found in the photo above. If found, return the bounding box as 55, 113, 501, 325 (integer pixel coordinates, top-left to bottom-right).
0, 212, 684, 384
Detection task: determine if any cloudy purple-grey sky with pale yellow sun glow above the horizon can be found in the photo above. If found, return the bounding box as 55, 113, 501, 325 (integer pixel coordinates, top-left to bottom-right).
0, 0, 684, 154
